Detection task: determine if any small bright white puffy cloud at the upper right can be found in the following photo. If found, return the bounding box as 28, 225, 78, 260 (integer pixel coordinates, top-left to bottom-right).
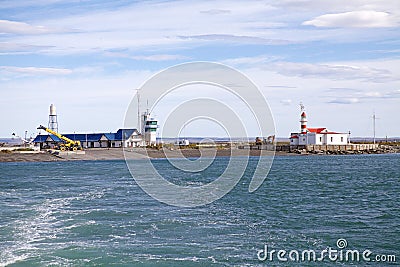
302, 10, 399, 28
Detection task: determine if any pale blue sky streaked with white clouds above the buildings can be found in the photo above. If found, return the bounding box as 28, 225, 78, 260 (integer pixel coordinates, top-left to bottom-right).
0, 0, 400, 137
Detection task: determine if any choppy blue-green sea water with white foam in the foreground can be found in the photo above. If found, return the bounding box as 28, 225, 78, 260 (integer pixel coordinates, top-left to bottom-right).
0, 155, 400, 266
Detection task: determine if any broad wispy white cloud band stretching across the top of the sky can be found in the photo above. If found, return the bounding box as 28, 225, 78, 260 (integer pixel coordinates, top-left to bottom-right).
2, 0, 399, 56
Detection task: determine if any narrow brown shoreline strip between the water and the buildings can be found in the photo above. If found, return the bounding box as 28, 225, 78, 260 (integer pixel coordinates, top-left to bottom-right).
0, 148, 399, 163
